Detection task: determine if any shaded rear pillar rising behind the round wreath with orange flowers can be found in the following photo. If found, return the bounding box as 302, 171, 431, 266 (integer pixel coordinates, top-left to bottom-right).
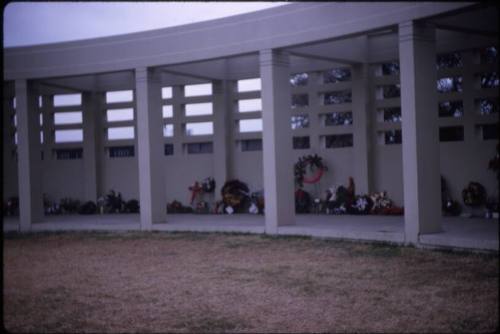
213, 80, 234, 197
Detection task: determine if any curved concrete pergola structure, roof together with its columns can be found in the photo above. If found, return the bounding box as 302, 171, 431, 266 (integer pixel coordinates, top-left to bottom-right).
4, 2, 498, 244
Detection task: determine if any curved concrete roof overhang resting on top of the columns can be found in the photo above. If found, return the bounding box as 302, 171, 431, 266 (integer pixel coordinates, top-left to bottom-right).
4, 3, 498, 94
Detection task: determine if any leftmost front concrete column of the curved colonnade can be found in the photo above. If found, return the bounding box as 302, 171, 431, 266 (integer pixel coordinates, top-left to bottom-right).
15, 79, 43, 231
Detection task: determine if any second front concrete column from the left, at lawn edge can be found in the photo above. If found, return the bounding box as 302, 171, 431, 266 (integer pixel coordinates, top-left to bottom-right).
135, 67, 166, 230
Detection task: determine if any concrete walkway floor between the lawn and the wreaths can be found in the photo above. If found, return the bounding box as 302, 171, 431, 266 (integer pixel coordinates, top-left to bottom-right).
3, 214, 499, 251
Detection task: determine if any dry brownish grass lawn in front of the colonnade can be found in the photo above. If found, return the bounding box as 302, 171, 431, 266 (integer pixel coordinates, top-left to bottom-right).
3, 232, 499, 333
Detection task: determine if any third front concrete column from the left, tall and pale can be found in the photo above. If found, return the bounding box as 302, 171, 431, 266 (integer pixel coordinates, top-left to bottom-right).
260, 50, 295, 233
